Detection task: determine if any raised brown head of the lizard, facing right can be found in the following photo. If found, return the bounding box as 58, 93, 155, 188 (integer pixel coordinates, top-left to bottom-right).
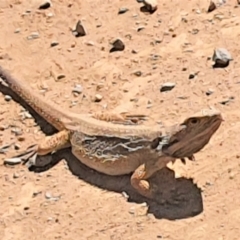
162, 109, 223, 158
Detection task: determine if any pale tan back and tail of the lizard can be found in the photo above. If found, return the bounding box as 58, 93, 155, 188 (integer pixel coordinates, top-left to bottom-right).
0, 66, 163, 140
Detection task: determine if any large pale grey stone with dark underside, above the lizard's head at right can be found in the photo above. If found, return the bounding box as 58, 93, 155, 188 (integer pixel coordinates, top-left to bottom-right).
212, 48, 233, 68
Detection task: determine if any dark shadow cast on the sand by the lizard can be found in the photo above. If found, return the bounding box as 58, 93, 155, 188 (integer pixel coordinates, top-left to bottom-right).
0, 84, 203, 220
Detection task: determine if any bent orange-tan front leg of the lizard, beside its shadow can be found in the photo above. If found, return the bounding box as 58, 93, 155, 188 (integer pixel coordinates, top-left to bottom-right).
131, 156, 175, 199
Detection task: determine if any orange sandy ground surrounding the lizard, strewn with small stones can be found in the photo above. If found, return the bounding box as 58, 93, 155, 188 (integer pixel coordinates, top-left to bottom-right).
0, 0, 240, 240
